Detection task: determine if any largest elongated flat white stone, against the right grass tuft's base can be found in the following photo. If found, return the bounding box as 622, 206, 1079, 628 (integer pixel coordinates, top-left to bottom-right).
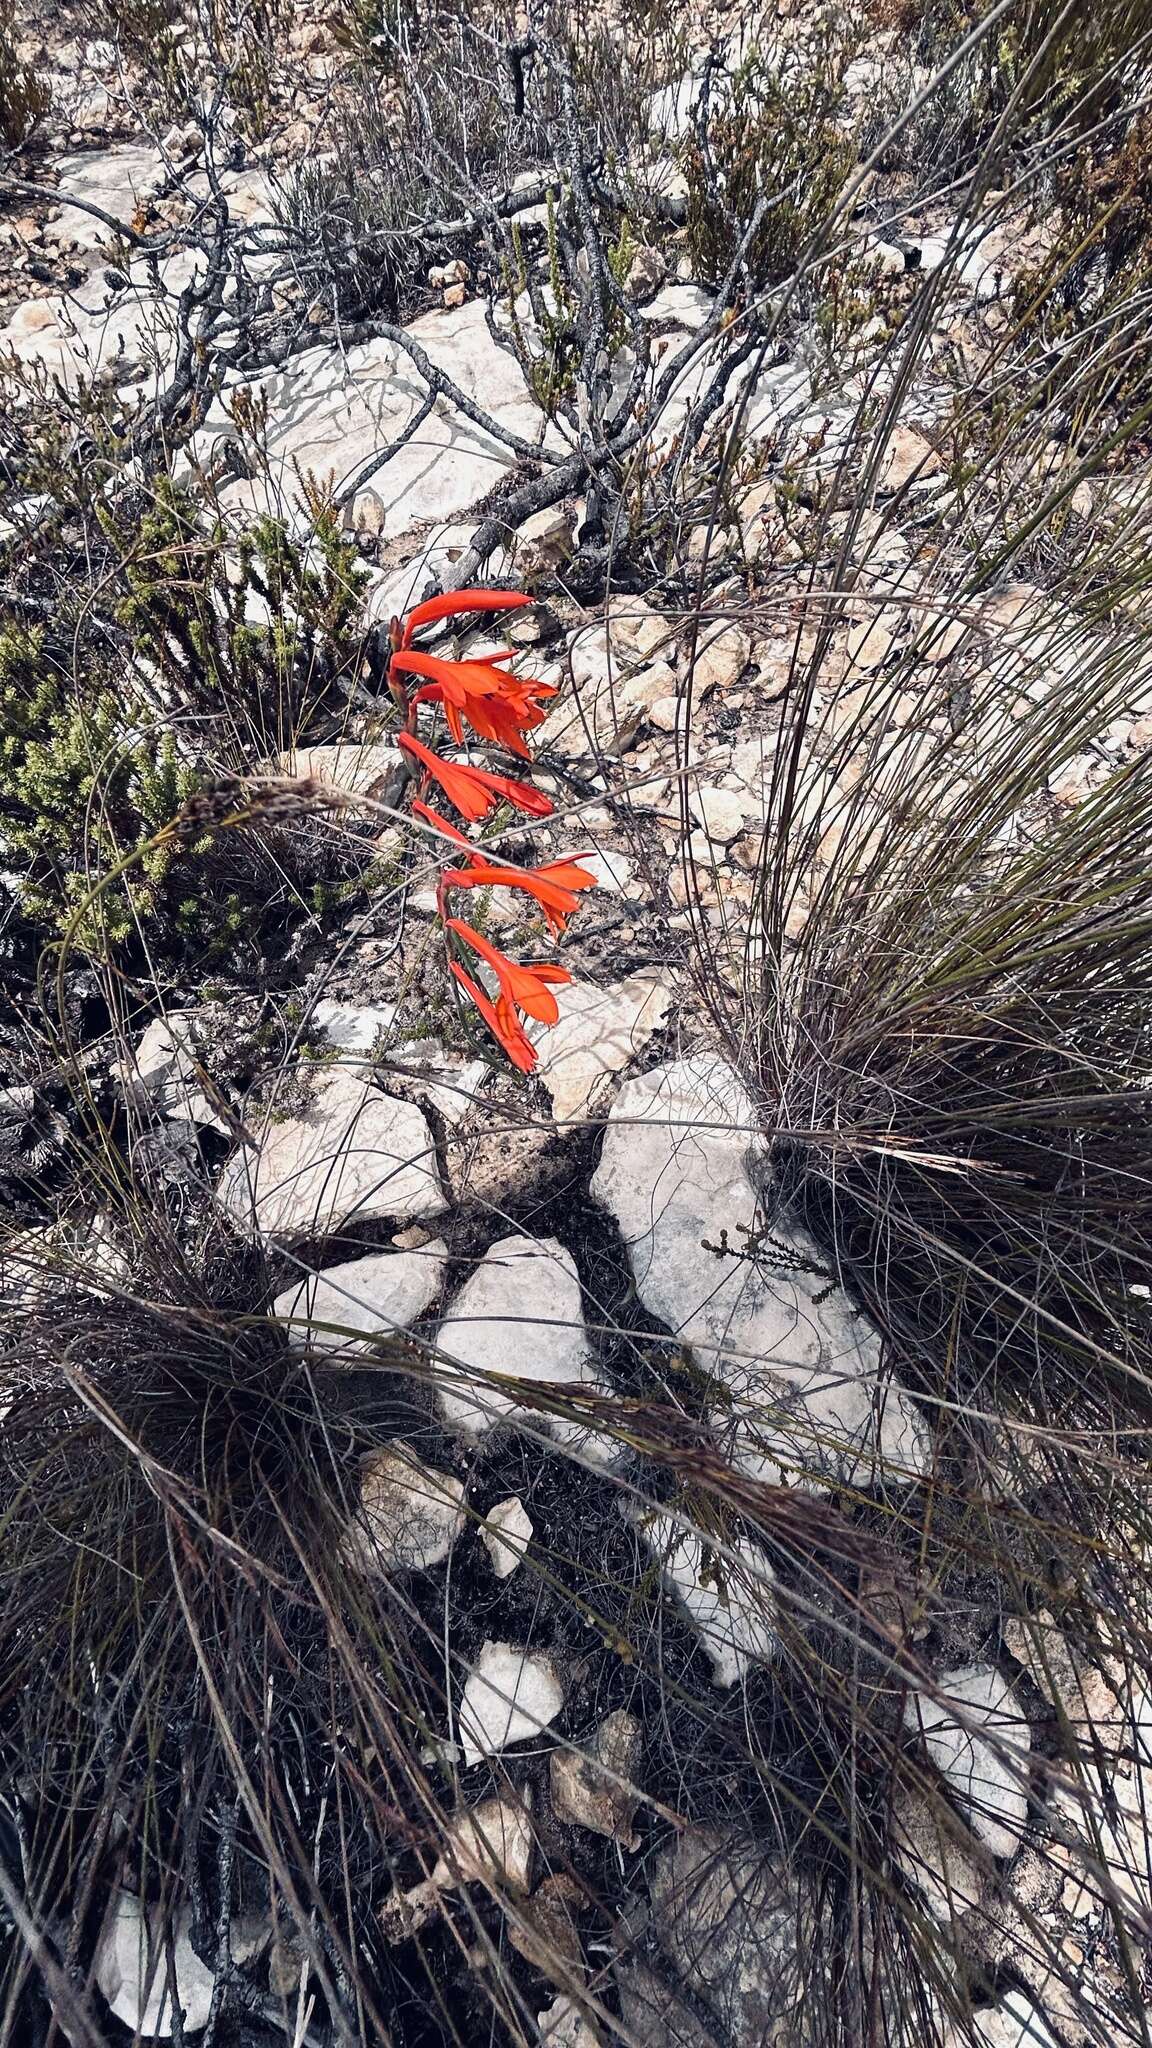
592, 1053, 929, 1485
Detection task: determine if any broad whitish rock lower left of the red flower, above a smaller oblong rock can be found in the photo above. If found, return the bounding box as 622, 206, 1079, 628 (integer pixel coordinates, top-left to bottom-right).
215, 1067, 445, 1237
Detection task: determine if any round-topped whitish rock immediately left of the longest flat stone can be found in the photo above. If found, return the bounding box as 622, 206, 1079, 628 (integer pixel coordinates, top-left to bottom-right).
437, 1237, 596, 1436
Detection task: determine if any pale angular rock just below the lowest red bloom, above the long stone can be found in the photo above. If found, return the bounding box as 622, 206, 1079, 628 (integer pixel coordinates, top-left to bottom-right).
531, 967, 672, 1124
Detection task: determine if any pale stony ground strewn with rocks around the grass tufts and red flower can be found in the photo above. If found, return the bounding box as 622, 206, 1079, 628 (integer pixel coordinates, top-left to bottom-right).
0, 6, 1152, 2048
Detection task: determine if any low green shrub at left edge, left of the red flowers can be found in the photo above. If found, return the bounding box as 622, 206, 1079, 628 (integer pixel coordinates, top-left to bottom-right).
0, 481, 363, 956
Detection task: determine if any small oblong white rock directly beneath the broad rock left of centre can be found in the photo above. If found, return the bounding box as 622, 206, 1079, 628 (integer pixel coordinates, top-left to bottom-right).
273, 1237, 449, 1364
